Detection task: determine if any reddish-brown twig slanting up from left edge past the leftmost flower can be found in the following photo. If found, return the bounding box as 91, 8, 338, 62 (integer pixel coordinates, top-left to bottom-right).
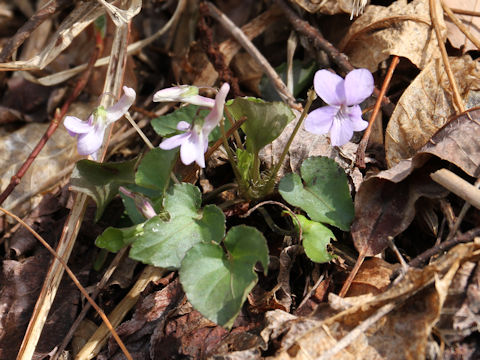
0, 33, 103, 205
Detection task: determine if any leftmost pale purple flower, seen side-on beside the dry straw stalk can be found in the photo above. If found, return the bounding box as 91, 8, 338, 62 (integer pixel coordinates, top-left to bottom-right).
63, 86, 136, 159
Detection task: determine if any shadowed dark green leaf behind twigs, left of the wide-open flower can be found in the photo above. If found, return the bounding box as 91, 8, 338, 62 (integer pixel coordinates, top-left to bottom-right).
259, 60, 318, 101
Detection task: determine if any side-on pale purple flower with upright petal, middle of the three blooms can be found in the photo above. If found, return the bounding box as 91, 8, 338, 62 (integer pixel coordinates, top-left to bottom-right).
160, 83, 230, 168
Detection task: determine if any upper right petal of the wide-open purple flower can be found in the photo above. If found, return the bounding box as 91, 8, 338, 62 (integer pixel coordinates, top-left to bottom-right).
344, 69, 374, 106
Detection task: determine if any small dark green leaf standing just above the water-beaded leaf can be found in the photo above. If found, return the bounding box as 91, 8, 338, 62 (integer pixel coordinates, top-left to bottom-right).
135, 148, 178, 194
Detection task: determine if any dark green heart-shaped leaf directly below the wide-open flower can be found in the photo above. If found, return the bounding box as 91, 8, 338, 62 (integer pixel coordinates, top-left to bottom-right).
278, 157, 354, 231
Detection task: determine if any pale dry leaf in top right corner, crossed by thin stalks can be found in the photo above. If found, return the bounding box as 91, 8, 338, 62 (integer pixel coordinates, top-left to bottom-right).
443, 0, 480, 53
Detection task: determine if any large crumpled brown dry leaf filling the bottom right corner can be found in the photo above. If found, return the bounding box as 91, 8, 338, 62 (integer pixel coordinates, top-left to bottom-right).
261, 243, 479, 359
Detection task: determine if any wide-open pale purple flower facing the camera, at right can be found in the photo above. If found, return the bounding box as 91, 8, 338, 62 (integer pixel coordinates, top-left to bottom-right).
305, 69, 374, 146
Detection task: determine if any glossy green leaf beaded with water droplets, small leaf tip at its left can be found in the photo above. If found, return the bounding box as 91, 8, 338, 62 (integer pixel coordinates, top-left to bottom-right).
96, 183, 225, 269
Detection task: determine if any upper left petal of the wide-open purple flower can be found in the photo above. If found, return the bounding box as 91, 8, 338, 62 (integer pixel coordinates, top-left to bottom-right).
313, 70, 345, 106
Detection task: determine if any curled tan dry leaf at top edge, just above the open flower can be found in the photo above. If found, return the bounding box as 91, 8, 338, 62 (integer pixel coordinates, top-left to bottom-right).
339, 0, 446, 72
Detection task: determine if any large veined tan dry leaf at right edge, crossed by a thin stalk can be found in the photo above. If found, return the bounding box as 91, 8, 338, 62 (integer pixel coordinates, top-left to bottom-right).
385, 55, 480, 167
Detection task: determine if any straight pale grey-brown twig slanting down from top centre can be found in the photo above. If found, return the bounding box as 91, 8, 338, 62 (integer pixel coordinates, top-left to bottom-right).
206, 2, 301, 109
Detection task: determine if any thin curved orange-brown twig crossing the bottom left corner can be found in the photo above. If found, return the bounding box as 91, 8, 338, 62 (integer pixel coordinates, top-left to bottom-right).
0, 207, 133, 360
